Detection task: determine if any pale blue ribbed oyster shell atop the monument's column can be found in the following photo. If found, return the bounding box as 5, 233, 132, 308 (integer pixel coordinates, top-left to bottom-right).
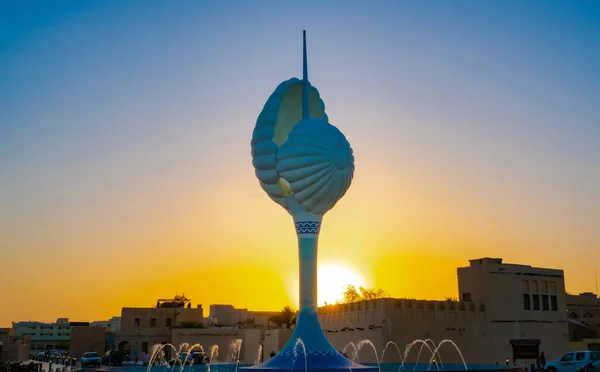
251, 38, 354, 216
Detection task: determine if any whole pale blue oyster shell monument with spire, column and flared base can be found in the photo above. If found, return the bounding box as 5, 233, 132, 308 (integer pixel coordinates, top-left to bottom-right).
244, 32, 377, 372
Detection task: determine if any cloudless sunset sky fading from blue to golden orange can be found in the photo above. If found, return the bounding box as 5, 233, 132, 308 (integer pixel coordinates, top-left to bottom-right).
0, 1, 600, 326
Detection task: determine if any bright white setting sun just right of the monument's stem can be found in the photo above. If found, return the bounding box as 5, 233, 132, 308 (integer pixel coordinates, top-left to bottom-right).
317, 264, 365, 306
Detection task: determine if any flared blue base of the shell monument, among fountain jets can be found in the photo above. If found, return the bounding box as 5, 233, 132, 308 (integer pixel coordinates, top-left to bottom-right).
241, 311, 377, 372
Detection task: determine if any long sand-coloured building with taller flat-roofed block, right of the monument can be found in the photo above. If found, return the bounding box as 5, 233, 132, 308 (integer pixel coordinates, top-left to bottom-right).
319, 258, 569, 365
